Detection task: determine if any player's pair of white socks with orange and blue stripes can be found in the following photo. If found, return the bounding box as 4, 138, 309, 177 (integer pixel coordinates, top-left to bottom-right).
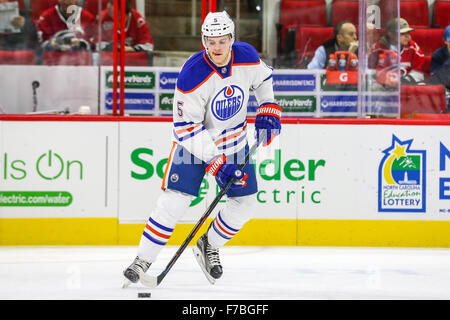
138, 189, 255, 262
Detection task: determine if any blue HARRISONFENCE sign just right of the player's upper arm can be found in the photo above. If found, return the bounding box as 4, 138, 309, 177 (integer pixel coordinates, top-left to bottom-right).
273, 74, 316, 92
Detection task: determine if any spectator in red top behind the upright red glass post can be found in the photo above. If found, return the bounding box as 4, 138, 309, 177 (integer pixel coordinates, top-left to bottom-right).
100, 0, 153, 52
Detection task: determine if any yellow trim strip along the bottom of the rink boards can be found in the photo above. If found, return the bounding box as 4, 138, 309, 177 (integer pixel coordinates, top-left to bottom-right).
0, 218, 450, 248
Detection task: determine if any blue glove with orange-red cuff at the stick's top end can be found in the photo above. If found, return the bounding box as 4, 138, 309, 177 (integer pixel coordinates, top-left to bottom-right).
255, 103, 281, 146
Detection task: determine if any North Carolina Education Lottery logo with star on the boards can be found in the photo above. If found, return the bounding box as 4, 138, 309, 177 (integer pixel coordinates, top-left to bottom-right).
378, 135, 426, 212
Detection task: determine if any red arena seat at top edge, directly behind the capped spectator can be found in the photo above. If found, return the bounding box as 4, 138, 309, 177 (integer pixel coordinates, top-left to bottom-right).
380, 0, 430, 28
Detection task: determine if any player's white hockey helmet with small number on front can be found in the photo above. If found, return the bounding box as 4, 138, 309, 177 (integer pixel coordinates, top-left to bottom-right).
202, 11, 234, 48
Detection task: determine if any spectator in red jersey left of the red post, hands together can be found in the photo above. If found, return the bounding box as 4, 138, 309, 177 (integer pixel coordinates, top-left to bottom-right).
37, 0, 97, 51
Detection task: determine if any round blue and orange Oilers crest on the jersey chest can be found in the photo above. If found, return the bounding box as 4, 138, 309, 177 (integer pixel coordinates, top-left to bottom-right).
211, 85, 244, 121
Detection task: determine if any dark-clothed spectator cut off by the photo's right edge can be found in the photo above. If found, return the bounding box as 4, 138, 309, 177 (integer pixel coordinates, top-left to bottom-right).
431, 25, 450, 91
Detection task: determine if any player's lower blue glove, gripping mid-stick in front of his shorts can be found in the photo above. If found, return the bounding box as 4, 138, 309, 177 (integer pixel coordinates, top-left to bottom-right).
205, 155, 248, 189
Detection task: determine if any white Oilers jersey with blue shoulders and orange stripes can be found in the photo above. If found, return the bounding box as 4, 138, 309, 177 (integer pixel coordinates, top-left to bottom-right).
173, 42, 275, 162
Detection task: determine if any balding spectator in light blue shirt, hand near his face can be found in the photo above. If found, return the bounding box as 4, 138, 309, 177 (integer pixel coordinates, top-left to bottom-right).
307, 21, 359, 69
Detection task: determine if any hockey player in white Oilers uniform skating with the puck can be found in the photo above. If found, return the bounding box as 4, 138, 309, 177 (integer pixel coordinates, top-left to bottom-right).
124, 11, 281, 285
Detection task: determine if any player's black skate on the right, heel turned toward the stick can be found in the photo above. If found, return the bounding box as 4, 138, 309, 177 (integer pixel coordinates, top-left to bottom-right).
192, 233, 223, 284
